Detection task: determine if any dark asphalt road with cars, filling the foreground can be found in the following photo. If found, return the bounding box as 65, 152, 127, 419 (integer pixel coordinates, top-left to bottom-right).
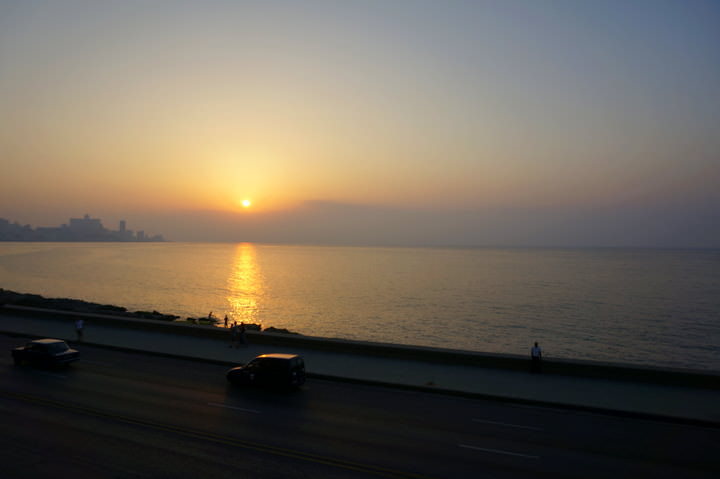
0, 336, 720, 479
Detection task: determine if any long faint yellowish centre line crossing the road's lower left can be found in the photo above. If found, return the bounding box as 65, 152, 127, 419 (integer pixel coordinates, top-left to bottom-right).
0, 389, 432, 479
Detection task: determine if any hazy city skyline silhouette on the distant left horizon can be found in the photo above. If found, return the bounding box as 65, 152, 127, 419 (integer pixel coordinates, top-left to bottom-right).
0, 214, 165, 242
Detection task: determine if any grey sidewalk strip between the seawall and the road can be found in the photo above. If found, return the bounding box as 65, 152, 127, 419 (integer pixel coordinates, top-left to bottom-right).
0, 313, 720, 427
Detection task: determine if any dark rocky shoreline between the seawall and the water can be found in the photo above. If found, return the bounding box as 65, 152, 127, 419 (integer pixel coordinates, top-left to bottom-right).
0, 288, 299, 334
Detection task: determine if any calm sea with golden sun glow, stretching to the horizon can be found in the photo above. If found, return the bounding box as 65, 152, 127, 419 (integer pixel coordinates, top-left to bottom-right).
0, 243, 720, 370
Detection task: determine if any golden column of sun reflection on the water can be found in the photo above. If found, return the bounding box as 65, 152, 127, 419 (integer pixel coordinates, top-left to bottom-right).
227, 243, 264, 324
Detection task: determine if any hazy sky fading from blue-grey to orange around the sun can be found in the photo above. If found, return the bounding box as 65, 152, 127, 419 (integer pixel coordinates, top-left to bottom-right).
0, 0, 720, 247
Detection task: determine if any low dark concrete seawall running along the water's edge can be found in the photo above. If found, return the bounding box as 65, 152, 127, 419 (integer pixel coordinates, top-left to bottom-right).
5, 305, 720, 390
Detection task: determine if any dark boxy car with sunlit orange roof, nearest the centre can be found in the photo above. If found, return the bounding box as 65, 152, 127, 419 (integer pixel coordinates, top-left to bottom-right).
227, 353, 305, 388
